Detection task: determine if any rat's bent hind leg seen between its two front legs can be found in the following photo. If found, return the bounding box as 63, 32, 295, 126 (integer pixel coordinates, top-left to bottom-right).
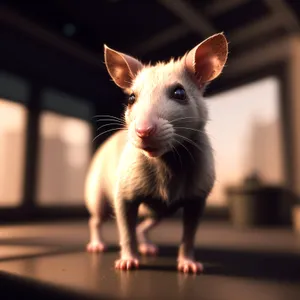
137, 216, 160, 255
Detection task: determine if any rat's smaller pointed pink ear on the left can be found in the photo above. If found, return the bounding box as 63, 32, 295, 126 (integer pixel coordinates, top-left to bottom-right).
104, 45, 143, 89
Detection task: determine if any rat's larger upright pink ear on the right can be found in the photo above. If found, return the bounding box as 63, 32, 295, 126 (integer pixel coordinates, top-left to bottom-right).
185, 33, 228, 87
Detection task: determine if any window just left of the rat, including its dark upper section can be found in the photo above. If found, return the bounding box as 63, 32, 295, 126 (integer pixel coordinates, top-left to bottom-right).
37, 88, 93, 206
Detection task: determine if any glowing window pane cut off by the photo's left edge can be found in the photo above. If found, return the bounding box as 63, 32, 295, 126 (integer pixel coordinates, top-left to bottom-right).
0, 99, 27, 207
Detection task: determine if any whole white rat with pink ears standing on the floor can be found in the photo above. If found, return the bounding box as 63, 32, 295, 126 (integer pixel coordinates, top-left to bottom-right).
85, 33, 228, 273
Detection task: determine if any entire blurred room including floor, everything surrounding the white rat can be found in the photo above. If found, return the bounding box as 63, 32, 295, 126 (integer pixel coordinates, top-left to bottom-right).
0, 0, 300, 300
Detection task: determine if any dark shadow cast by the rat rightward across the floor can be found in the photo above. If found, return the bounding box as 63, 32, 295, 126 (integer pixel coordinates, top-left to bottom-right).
135, 246, 300, 282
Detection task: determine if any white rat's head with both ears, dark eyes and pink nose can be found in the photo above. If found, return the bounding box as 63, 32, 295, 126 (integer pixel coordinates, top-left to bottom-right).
104, 33, 228, 157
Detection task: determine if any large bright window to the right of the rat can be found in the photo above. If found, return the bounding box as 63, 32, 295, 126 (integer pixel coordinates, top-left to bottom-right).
207, 77, 284, 205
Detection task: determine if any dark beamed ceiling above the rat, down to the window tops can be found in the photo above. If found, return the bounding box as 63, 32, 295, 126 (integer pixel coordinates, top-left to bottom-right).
0, 0, 300, 106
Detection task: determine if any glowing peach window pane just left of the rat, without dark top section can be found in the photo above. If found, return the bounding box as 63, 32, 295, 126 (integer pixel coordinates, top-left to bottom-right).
37, 112, 92, 205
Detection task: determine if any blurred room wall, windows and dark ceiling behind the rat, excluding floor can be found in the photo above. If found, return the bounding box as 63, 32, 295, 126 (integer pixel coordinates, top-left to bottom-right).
0, 0, 300, 229
